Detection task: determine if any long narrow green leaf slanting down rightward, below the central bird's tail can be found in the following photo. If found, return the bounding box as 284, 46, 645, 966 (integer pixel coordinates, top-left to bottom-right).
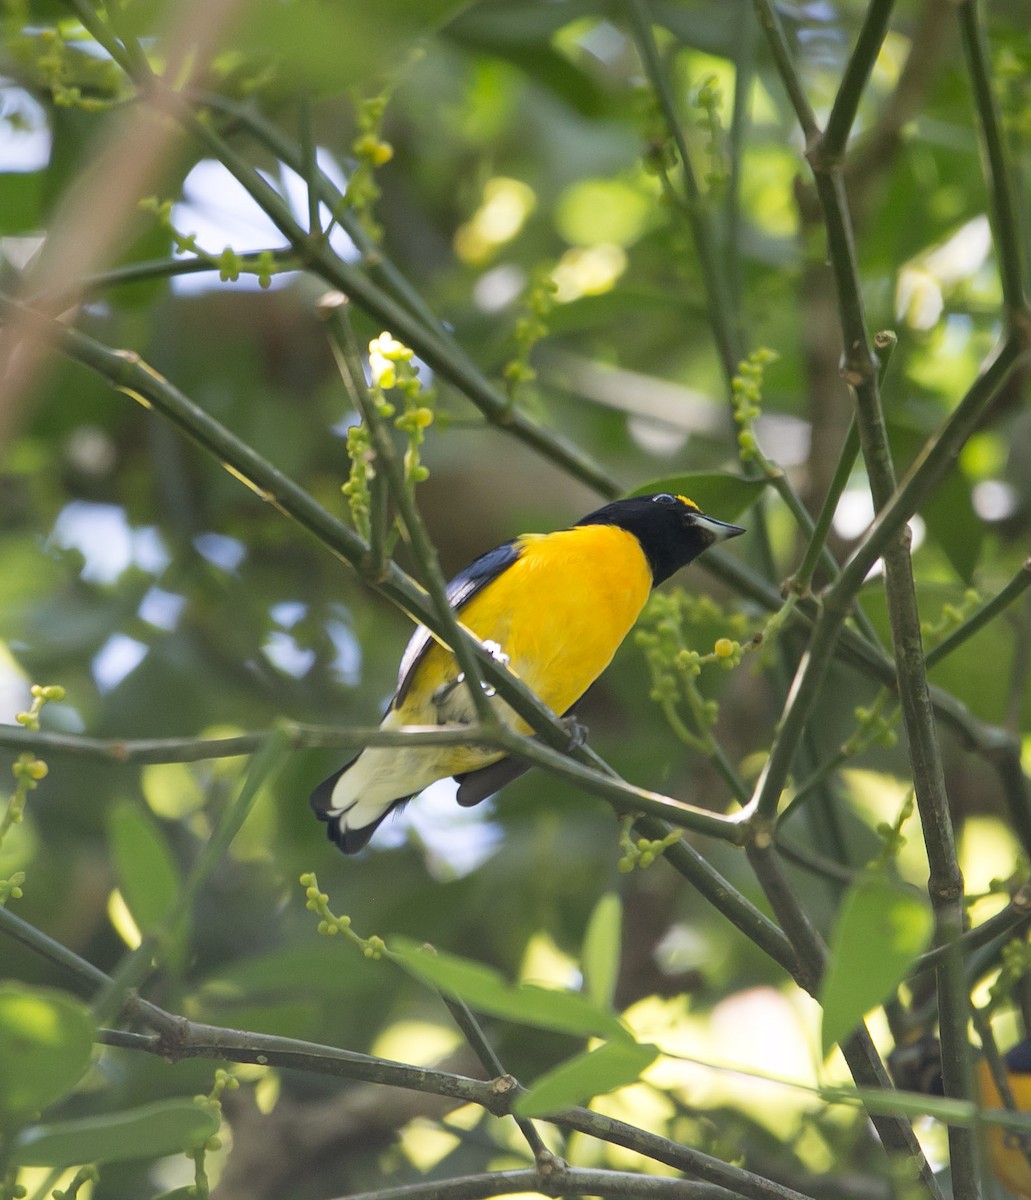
390, 937, 630, 1042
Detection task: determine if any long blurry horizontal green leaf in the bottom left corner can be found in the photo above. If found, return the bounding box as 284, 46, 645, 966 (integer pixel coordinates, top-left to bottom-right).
11, 1100, 218, 1166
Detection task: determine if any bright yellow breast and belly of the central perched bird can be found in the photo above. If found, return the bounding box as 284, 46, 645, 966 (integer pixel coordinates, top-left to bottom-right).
398, 526, 652, 730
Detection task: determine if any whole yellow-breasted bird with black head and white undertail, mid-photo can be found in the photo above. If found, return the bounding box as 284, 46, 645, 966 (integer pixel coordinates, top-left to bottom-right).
311, 492, 745, 854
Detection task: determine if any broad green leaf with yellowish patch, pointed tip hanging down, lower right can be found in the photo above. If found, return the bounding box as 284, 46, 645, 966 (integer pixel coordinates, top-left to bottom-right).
820, 875, 934, 1055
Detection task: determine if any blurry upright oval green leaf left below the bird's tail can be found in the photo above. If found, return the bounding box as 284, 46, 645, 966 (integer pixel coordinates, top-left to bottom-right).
108, 800, 182, 934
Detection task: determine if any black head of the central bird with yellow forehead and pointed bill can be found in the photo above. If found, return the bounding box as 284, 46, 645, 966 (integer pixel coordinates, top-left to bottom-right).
576, 492, 744, 586
